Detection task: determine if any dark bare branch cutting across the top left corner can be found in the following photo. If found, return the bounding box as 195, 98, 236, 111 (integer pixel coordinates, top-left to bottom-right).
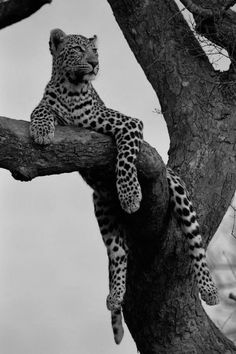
0, 0, 52, 29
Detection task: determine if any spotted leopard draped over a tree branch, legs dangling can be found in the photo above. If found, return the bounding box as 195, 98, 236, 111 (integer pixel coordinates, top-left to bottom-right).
29, 28, 219, 344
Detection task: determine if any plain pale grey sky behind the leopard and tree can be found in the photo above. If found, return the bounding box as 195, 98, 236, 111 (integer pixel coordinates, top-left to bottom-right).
0, 0, 235, 354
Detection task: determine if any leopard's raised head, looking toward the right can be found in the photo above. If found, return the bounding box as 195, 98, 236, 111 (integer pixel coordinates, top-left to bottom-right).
49, 29, 99, 85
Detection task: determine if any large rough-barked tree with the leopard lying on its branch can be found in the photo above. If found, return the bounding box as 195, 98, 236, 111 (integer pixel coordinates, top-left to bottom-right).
0, 0, 236, 354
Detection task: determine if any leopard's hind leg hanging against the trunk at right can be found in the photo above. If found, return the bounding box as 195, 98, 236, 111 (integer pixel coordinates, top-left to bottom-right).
167, 168, 219, 305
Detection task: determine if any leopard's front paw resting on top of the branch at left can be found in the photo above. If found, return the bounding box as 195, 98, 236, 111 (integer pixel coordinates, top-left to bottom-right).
30, 124, 55, 145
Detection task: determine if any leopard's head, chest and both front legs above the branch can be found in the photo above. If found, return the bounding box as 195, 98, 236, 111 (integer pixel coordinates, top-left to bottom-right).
30, 29, 143, 213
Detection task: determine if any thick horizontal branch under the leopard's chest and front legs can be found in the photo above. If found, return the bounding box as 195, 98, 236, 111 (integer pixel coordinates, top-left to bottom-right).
0, 117, 164, 181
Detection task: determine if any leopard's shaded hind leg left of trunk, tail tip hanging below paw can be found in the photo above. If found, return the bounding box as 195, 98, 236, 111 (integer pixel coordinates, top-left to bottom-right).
93, 191, 128, 344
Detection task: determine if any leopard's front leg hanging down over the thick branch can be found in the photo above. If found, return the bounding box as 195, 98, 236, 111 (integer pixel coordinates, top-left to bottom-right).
89, 106, 143, 214
